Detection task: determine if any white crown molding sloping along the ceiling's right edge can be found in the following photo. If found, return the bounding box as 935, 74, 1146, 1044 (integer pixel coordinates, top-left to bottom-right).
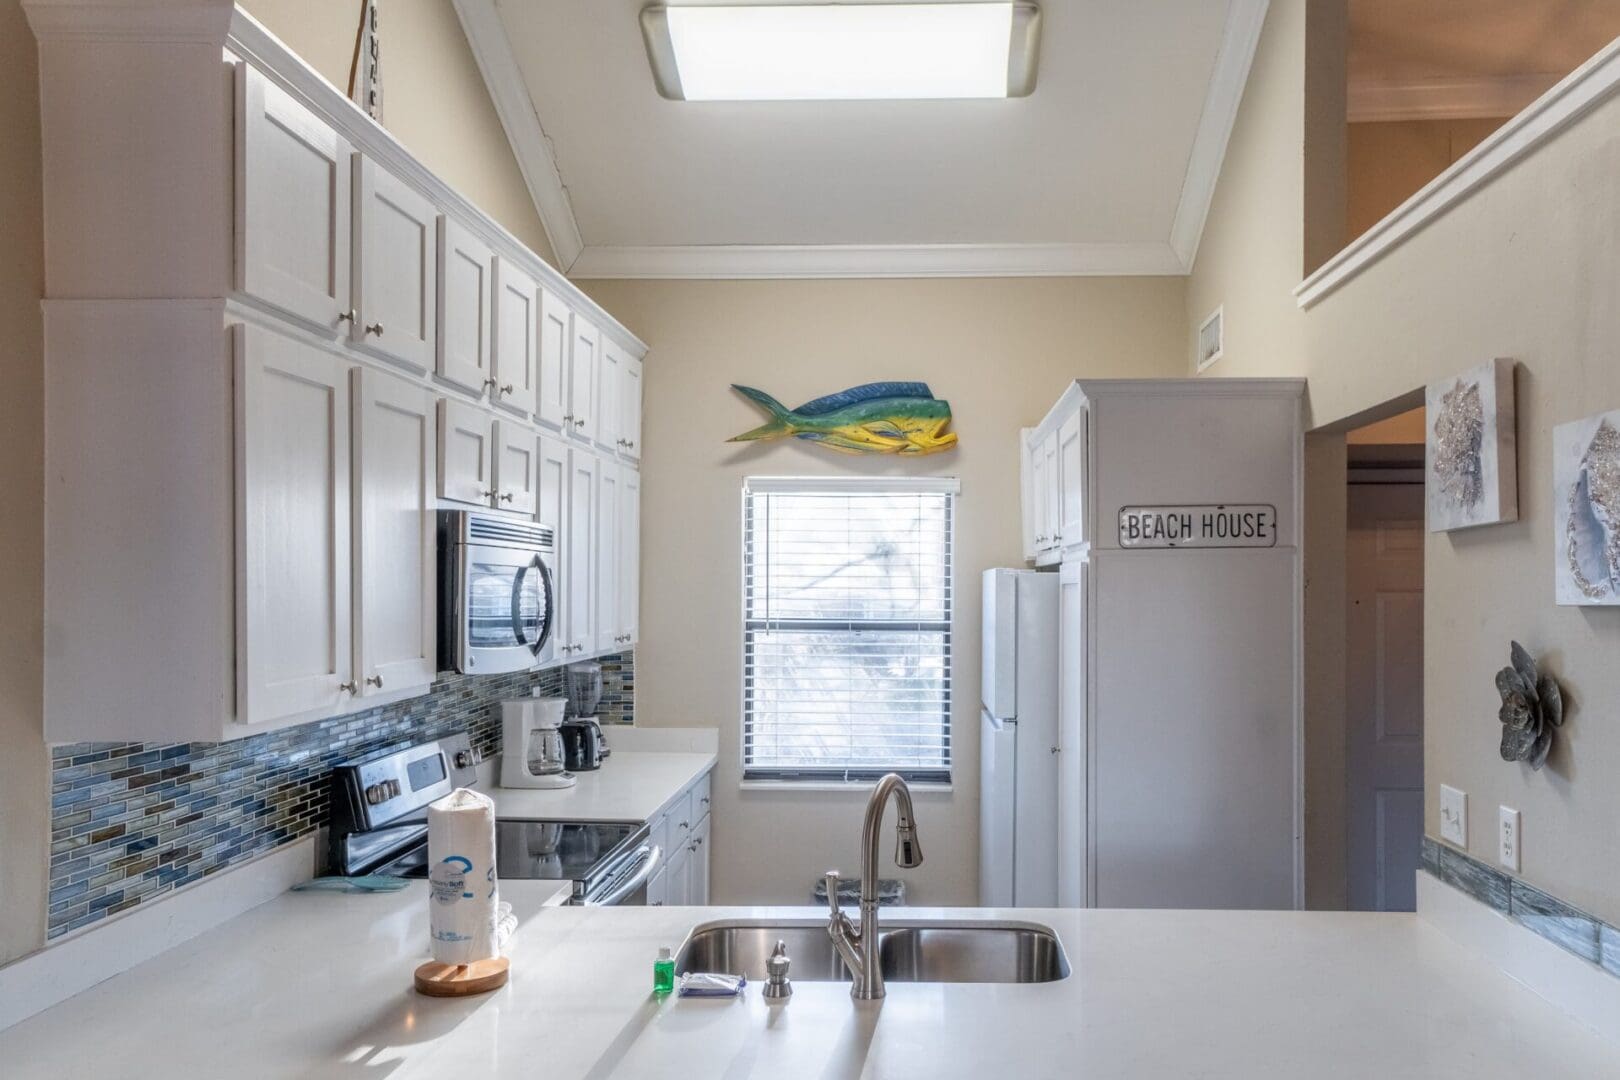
1170, 0, 1270, 274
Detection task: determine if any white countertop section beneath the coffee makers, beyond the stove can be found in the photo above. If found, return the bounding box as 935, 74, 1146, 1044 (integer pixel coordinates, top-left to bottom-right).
480, 748, 714, 821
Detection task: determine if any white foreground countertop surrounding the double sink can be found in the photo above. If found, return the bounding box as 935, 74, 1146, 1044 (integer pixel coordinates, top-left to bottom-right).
0, 881, 1620, 1080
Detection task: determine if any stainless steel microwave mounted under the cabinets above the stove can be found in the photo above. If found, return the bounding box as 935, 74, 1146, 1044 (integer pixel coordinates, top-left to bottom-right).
439, 510, 557, 675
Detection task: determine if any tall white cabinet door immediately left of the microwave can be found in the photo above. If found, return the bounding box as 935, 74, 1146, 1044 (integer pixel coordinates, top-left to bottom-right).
353, 368, 439, 696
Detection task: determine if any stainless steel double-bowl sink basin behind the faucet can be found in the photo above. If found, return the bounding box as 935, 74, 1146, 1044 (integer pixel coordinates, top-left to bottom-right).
676, 920, 1069, 983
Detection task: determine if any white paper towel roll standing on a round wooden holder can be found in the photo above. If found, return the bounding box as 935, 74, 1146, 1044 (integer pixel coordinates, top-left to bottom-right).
428, 787, 501, 963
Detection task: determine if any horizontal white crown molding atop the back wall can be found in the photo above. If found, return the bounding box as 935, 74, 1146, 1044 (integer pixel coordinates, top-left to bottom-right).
569, 243, 1186, 280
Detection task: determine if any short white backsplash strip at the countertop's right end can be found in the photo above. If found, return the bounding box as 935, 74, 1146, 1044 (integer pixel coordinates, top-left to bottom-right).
1418, 871, 1620, 1043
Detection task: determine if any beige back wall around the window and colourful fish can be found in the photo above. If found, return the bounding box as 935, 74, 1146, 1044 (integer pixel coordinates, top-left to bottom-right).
582, 279, 1187, 904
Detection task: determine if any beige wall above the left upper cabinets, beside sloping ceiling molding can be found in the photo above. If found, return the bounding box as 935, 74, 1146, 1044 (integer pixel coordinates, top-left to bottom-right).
241, 0, 556, 264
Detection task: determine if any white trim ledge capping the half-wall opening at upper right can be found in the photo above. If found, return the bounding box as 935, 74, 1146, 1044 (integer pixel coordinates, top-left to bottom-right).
1294, 39, 1620, 308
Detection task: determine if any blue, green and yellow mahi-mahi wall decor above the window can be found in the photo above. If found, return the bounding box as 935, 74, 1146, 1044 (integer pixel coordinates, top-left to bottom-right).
731, 382, 956, 453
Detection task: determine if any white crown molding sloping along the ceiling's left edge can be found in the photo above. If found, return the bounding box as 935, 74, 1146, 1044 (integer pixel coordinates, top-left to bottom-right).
454, 0, 585, 274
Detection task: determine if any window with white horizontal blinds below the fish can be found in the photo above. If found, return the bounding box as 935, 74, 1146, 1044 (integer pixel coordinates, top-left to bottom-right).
742, 478, 956, 782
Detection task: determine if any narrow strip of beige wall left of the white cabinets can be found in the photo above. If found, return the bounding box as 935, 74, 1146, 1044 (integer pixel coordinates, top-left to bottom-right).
0, 0, 50, 963
